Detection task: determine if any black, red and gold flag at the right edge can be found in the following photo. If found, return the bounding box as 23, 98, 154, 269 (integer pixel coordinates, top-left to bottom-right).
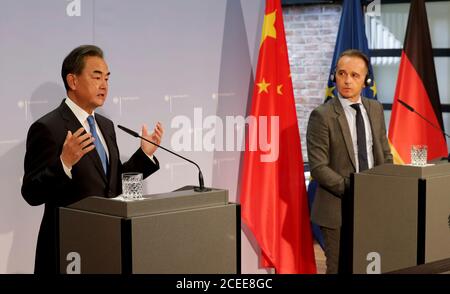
388, 0, 447, 164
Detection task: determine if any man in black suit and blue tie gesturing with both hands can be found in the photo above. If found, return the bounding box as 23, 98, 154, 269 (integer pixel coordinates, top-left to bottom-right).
22, 45, 163, 274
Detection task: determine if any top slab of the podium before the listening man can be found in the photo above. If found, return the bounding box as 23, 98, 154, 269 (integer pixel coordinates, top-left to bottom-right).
361, 161, 450, 179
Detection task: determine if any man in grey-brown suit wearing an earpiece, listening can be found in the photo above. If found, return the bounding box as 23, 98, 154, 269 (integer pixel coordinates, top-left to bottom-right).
306, 50, 392, 273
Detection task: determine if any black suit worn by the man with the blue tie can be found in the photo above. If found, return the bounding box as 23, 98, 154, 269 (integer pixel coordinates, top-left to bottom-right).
22, 101, 159, 273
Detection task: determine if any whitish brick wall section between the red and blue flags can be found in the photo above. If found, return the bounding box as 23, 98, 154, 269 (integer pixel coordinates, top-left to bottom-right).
283, 4, 342, 162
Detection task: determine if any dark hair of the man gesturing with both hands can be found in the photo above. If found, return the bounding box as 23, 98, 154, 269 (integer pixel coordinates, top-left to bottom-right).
61, 45, 103, 91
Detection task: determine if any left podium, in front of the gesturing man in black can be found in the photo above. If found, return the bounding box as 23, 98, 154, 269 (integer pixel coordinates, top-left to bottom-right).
59, 186, 241, 274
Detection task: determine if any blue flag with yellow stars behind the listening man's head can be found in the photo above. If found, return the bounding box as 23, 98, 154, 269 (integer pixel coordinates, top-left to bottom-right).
325, 0, 377, 100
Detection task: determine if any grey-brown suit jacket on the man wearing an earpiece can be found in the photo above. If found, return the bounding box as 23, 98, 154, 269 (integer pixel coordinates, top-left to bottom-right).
306, 97, 392, 228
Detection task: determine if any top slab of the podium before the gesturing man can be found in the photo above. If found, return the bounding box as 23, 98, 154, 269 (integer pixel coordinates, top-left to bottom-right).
68, 186, 228, 218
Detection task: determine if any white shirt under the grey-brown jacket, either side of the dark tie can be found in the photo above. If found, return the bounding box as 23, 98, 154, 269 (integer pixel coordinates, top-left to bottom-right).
339, 95, 374, 172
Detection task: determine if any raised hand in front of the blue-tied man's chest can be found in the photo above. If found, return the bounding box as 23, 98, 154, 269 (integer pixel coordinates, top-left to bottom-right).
61, 128, 95, 168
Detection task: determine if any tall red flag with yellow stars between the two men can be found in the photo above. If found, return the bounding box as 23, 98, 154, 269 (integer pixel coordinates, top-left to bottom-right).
240, 0, 316, 274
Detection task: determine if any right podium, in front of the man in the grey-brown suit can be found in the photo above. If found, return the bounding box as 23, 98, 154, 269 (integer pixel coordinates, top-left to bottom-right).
342, 162, 450, 273
